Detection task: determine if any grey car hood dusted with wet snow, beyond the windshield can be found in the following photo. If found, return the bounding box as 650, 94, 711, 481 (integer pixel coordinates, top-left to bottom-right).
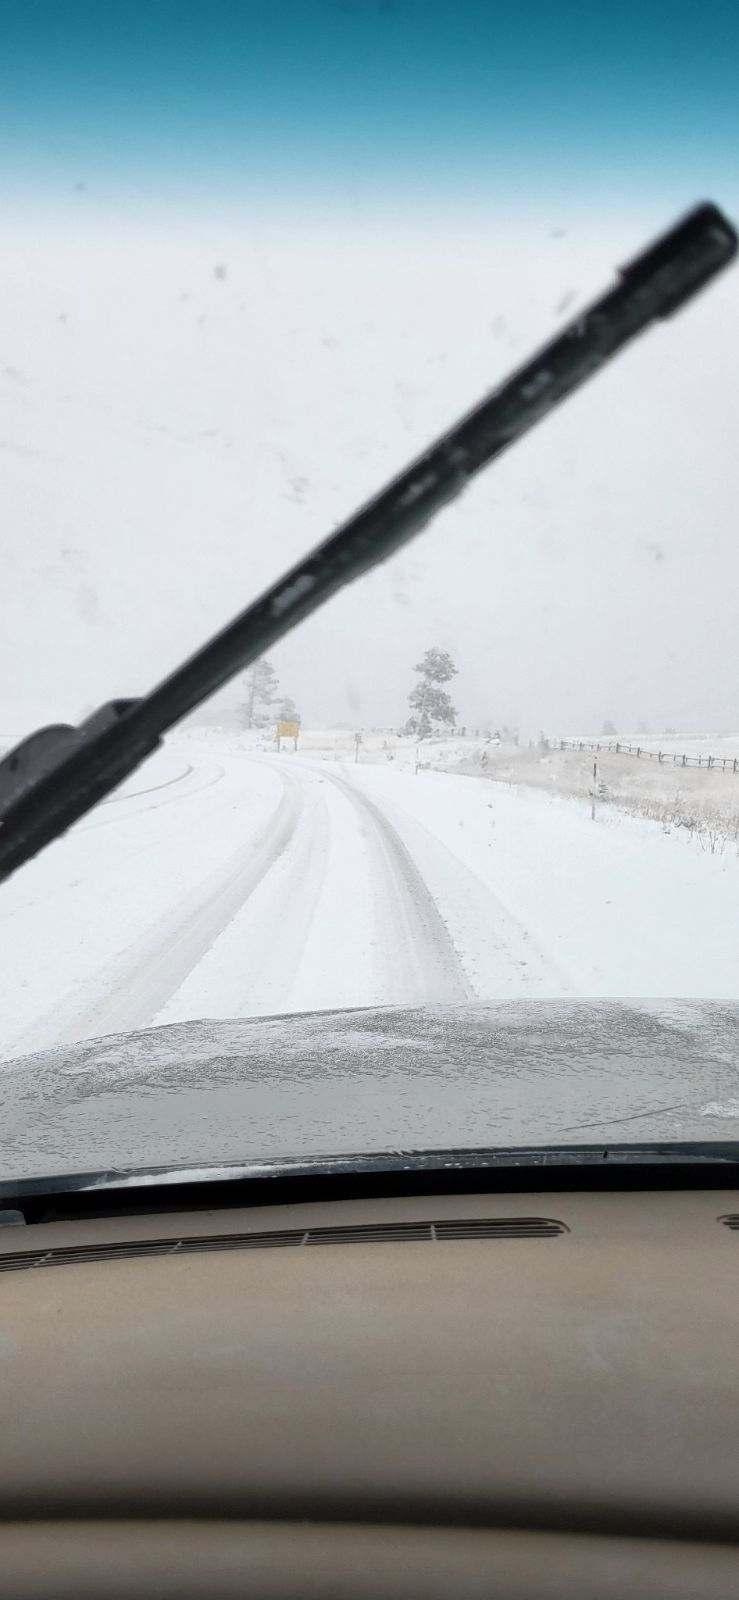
0, 1000, 739, 1179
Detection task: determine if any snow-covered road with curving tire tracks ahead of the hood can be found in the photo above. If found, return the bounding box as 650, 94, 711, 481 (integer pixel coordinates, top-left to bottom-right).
0, 734, 739, 1058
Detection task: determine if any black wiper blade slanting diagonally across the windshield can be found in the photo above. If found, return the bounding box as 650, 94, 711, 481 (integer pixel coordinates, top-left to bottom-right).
0, 203, 737, 880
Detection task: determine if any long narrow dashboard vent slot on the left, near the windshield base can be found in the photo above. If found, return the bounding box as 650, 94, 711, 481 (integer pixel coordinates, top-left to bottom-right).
0, 1216, 566, 1272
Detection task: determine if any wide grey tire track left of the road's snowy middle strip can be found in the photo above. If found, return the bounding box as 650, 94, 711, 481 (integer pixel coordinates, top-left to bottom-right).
36, 773, 302, 1043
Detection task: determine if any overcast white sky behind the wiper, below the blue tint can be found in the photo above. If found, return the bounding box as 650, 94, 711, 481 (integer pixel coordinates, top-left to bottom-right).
0, 195, 739, 733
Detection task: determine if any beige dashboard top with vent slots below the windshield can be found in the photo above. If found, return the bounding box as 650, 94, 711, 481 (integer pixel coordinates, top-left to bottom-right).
0, 1190, 739, 1600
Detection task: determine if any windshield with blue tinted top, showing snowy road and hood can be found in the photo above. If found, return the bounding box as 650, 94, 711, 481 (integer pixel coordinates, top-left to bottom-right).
0, 0, 739, 1176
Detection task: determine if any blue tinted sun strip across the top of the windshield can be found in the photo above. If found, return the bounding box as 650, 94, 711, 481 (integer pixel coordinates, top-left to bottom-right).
0, 0, 739, 211
